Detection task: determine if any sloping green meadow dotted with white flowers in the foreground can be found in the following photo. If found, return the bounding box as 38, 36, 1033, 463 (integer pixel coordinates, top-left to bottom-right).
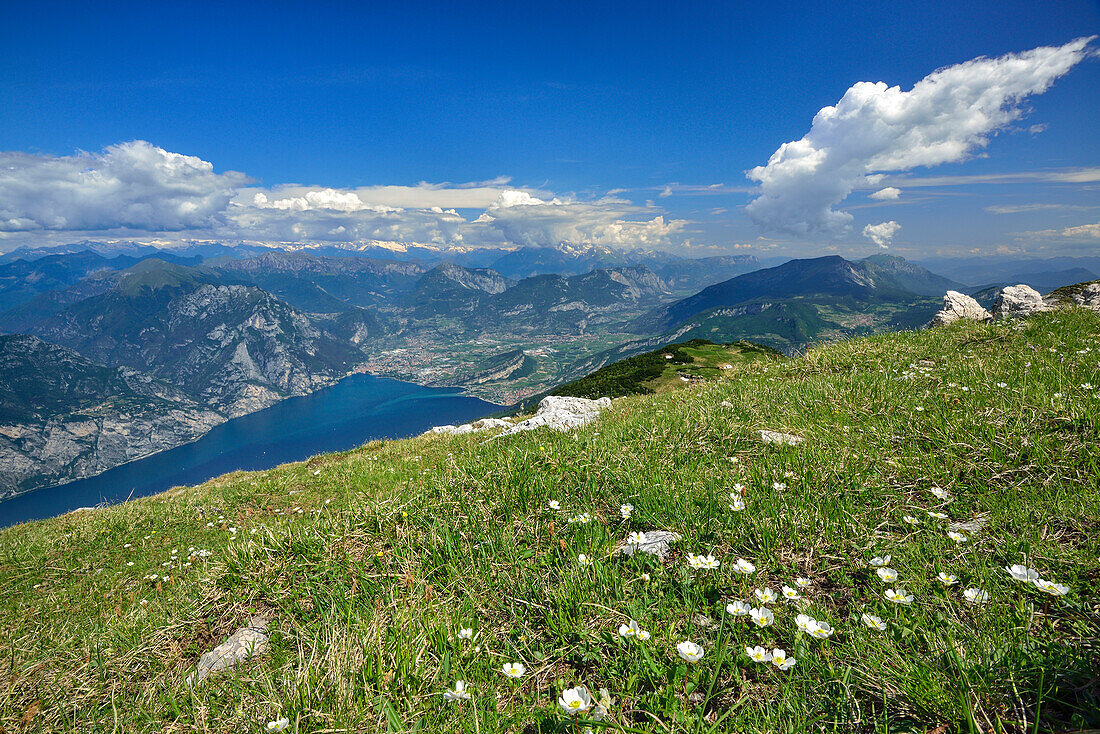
0, 310, 1100, 734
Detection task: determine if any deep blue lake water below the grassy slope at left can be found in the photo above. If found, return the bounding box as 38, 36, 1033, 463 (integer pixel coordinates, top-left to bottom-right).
0, 374, 502, 527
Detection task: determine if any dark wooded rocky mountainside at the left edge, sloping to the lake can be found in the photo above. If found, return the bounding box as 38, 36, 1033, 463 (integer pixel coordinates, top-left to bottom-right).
0, 335, 226, 499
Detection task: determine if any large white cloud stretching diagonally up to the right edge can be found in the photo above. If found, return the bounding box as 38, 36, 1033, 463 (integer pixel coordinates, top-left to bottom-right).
746, 36, 1095, 235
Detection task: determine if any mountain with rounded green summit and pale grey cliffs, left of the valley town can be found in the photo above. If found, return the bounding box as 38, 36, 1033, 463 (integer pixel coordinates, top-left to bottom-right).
4, 261, 356, 416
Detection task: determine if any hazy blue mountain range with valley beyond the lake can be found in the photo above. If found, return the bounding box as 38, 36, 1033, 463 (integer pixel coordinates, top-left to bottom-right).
0, 244, 1012, 499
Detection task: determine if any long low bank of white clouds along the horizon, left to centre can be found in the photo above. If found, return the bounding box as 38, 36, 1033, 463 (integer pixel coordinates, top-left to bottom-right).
0, 141, 685, 253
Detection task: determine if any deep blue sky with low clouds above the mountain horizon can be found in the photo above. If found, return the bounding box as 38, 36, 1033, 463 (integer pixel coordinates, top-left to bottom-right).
0, 1, 1100, 256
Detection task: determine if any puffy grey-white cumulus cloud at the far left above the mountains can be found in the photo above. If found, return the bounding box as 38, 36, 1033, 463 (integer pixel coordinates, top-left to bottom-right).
0, 141, 248, 232
